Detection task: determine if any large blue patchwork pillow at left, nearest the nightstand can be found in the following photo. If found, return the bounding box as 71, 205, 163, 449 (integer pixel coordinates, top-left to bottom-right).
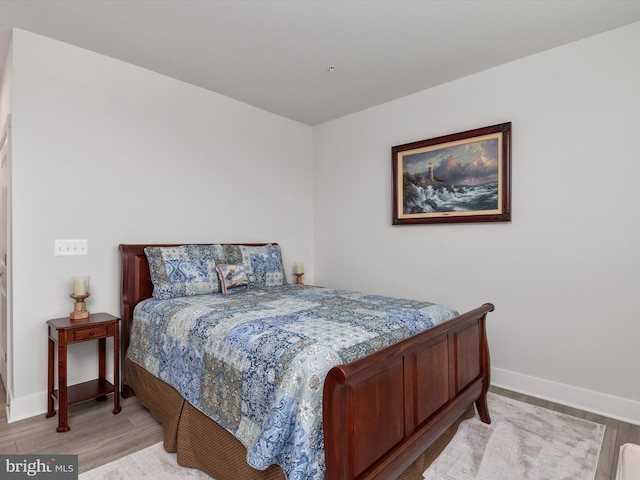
144, 245, 224, 299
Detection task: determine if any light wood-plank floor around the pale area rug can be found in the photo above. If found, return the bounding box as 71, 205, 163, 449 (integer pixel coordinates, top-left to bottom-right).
0, 382, 640, 480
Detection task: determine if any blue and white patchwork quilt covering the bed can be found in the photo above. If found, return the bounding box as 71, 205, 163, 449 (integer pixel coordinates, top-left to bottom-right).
128, 285, 457, 480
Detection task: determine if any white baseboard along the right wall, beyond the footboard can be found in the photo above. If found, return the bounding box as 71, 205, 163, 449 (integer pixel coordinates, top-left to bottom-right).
491, 368, 640, 425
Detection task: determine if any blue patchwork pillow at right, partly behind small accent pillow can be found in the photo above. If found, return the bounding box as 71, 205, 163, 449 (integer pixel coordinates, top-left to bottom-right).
240, 244, 287, 288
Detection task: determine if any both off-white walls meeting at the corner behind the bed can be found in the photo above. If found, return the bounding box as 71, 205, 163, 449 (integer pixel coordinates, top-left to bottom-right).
0, 24, 640, 423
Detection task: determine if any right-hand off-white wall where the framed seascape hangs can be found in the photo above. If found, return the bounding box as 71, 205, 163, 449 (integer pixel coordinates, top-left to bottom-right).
314, 23, 640, 423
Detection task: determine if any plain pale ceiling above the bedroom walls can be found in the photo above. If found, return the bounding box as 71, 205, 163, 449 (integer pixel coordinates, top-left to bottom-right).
0, 0, 640, 125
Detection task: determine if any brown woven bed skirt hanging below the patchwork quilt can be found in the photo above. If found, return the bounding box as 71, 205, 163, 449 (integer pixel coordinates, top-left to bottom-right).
124, 359, 475, 480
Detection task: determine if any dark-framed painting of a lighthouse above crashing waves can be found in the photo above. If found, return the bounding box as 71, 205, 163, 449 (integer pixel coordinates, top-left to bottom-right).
391, 122, 511, 225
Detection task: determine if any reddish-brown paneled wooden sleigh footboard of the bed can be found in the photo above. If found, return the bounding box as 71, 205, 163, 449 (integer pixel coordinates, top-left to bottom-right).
323, 304, 494, 480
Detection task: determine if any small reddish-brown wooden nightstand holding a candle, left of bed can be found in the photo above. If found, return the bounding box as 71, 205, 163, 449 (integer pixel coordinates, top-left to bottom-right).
46, 313, 122, 432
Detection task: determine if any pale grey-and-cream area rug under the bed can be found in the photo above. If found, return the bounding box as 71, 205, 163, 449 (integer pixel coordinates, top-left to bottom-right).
79, 394, 605, 480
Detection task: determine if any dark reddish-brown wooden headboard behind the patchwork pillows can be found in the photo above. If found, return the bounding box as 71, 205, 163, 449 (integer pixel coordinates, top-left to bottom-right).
120, 242, 278, 398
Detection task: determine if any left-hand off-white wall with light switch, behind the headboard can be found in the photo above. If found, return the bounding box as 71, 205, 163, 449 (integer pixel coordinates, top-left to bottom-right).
5, 30, 313, 421
